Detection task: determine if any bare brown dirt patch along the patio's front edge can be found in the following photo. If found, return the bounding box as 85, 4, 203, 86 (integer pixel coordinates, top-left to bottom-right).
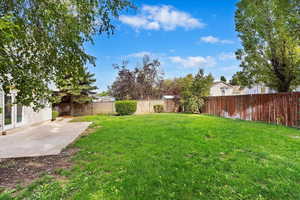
0, 148, 79, 192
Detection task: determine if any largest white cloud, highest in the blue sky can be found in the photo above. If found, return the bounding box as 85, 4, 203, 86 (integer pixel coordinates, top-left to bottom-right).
119, 5, 205, 31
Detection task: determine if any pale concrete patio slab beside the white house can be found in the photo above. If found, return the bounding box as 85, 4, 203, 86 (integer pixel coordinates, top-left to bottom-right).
0, 119, 91, 159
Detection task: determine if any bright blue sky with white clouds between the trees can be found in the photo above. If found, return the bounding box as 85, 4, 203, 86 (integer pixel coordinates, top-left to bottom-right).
85, 0, 241, 91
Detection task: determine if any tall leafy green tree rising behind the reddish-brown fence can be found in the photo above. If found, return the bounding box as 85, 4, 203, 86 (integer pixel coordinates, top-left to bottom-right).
235, 0, 300, 92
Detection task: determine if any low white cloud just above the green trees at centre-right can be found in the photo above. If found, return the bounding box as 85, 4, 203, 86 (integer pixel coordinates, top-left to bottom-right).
169, 56, 216, 68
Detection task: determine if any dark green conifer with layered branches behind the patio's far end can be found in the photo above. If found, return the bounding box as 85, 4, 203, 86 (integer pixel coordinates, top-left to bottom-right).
55, 69, 98, 115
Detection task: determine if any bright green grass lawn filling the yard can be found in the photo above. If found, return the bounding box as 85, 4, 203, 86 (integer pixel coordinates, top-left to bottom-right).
0, 114, 300, 200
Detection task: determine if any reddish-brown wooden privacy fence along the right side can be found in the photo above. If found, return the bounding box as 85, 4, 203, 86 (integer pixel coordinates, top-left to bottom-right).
204, 92, 300, 127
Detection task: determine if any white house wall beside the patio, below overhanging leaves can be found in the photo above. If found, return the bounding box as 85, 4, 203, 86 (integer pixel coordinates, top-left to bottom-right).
0, 90, 52, 131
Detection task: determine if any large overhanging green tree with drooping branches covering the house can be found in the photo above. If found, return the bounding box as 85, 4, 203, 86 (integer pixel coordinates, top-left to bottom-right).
0, 0, 131, 108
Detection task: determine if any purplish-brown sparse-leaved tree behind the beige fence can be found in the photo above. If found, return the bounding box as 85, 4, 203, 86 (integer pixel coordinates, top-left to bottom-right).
109, 56, 163, 100
